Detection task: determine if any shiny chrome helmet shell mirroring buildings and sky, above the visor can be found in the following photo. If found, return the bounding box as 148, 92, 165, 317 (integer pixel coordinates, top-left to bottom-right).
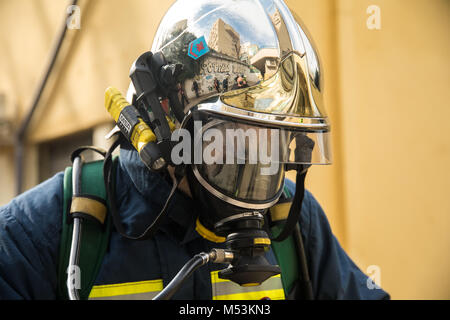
152, 0, 328, 131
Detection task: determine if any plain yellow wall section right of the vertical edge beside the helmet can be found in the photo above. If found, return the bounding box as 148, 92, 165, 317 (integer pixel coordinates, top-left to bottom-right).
337, 0, 450, 298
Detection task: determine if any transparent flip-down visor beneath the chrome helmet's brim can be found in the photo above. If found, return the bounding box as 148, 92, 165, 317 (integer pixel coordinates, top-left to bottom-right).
194, 113, 331, 166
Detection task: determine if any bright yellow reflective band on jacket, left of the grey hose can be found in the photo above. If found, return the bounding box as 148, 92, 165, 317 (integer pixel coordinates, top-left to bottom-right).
89, 279, 163, 299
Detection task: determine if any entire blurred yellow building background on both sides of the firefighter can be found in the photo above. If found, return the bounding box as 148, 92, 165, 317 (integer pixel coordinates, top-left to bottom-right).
0, 0, 450, 299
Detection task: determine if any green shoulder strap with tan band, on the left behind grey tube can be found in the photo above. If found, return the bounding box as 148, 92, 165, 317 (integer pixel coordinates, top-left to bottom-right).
58, 161, 111, 300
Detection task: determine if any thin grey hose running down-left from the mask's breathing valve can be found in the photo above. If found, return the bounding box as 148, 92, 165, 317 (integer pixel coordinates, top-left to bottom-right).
153, 252, 209, 300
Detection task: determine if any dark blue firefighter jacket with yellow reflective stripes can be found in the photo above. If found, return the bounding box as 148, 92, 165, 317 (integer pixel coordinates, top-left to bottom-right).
0, 149, 389, 299
